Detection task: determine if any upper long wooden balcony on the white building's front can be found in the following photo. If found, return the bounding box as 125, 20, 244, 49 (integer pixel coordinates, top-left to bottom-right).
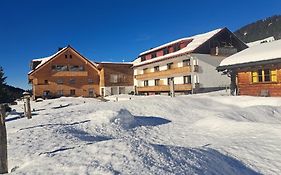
136, 66, 191, 80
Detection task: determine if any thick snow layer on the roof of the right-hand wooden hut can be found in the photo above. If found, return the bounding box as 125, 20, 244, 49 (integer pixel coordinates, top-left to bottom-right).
220, 40, 281, 66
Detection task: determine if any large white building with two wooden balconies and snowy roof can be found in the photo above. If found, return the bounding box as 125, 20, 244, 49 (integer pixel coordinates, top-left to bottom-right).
133, 28, 248, 94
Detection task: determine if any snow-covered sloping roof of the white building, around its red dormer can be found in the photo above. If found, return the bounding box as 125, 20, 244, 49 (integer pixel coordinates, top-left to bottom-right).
134, 28, 223, 66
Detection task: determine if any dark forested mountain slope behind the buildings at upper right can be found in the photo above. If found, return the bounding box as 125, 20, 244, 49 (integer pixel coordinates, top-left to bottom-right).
234, 15, 281, 43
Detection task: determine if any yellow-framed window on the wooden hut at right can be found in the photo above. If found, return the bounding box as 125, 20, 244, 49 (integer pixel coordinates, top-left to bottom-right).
252, 69, 277, 83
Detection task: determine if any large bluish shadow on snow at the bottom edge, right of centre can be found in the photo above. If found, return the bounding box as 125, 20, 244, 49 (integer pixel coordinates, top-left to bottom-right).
144, 144, 260, 175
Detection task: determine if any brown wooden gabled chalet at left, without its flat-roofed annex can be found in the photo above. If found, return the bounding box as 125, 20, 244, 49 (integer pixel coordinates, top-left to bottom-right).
28, 46, 100, 97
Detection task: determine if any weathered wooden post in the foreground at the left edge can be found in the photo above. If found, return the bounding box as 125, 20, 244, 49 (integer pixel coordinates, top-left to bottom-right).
0, 105, 8, 174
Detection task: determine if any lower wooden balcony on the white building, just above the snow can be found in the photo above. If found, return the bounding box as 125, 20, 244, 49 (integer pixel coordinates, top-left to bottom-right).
137, 84, 192, 92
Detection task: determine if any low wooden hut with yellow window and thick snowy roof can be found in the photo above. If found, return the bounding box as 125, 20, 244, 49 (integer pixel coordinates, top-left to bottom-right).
217, 40, 281, 96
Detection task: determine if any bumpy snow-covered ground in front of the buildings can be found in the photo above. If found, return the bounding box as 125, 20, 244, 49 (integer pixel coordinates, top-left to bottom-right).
4, 92, 281, 175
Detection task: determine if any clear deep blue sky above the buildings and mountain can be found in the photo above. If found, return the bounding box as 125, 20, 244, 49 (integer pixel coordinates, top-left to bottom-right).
0, 0, 281, 89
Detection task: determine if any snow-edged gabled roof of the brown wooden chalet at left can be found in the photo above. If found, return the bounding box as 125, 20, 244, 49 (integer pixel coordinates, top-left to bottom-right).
28, 45, 98, 75
